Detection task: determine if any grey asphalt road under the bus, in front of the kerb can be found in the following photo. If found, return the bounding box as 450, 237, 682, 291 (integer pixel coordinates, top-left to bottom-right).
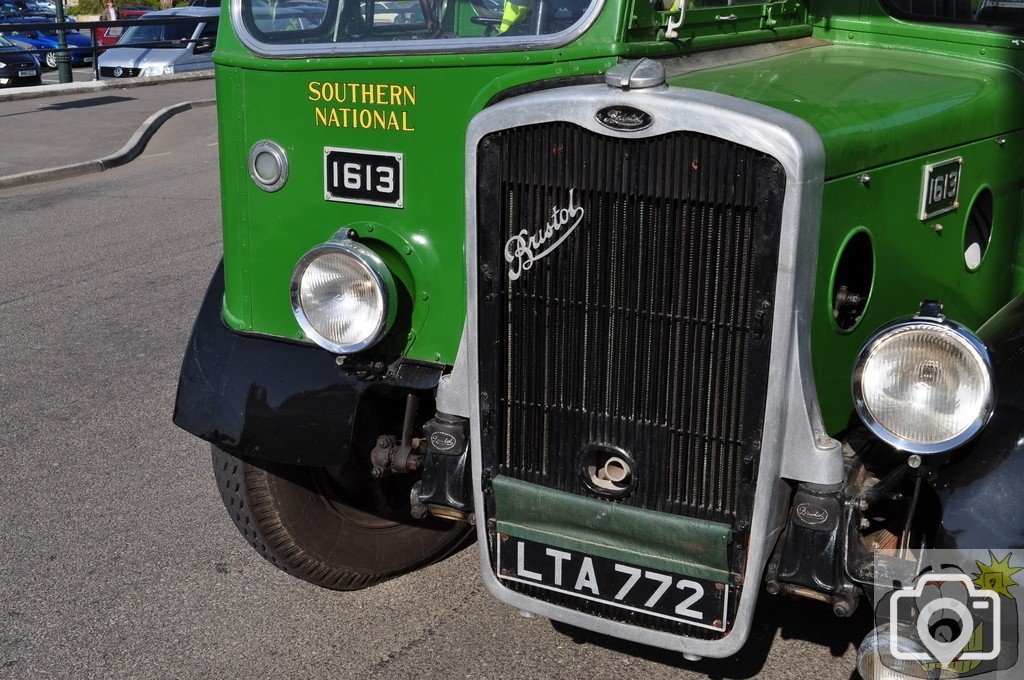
0, 110, 867, 680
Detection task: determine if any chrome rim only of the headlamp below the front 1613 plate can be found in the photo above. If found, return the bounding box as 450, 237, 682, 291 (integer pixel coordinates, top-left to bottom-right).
289, 237, 397, 354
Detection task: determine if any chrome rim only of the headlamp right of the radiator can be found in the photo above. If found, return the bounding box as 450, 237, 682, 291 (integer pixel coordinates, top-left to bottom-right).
851, 314, 995, 456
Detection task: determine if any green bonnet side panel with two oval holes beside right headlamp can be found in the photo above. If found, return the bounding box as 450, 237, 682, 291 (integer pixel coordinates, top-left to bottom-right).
811, 132, 1024, 433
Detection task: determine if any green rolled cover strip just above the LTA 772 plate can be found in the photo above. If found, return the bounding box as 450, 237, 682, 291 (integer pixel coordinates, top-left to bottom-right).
492, 476, 731, 583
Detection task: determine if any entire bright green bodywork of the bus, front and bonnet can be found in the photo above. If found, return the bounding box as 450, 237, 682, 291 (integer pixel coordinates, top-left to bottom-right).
209, 0, 1024, 433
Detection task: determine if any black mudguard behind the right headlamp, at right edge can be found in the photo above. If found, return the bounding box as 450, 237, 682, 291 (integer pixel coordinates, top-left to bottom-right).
934, 295, 1024, 549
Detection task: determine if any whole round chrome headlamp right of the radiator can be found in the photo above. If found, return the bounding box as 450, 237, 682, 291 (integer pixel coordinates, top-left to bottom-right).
853, 303, 995, 455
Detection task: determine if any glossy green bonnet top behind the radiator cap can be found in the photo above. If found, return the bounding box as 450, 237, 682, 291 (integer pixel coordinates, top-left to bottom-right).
669, 45, 1024, 178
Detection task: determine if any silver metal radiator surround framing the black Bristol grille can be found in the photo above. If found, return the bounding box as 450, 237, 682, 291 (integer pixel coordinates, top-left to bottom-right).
464, 85, 843, 657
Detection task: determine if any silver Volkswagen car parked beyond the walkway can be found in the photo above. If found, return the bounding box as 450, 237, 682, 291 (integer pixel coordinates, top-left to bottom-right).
99, 7, 220, 78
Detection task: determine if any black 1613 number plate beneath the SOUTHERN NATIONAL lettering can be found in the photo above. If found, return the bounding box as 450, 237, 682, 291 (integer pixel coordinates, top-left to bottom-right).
324, 146, 404, 208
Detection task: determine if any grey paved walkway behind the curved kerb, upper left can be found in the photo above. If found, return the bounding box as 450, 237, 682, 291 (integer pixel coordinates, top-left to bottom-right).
0, 79, 214, 176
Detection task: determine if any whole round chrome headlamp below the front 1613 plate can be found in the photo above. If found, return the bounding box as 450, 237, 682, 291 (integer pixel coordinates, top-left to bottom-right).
291, 236, 396, 354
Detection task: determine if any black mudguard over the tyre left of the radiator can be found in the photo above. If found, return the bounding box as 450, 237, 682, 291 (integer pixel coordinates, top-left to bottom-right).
174, 263, 441, 466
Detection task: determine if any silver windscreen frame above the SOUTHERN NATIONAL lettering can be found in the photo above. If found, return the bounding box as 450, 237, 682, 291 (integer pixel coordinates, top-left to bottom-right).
230, 0, 605, 58
